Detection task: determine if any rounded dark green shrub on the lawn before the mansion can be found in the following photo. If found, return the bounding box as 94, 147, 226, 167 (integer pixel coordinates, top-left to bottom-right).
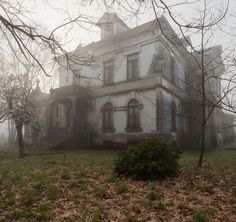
114, 139, 180, 180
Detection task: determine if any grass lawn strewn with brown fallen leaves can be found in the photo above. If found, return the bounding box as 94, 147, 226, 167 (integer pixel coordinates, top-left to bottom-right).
0, 149, 236, 222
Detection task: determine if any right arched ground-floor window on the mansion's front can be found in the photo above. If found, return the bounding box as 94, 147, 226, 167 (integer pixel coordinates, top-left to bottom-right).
127, 99, 140, 129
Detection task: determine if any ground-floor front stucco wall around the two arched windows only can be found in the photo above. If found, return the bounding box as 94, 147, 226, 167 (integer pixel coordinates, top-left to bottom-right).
90, 90, 156, 134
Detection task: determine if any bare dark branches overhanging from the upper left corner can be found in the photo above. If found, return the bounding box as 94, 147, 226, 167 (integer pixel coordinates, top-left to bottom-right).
0, 0, 97, 77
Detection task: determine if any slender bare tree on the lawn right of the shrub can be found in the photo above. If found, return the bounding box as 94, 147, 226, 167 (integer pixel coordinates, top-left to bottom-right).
149, 0, 235, 167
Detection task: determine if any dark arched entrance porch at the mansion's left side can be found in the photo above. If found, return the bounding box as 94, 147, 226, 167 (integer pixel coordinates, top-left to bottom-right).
47, 85, 90, 148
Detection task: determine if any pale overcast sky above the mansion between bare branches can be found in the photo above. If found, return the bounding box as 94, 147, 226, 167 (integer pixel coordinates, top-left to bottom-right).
22, 0, 236, 50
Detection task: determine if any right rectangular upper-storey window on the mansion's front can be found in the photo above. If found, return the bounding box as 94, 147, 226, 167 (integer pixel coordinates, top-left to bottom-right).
127, 53, 139, 80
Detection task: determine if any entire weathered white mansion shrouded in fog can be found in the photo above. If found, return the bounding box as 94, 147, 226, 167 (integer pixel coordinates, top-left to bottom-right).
28, 13, 233, 147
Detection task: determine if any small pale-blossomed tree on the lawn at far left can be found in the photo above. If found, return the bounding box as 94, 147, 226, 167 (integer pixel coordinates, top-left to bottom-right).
0, 70, 40, 157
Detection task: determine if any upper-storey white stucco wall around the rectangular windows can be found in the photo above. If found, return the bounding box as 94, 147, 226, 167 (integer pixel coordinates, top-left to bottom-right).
59, 37, 185, 89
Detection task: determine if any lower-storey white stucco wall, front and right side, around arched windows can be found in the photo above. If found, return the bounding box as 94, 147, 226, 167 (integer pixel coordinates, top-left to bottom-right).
89, 89, 183, 146
